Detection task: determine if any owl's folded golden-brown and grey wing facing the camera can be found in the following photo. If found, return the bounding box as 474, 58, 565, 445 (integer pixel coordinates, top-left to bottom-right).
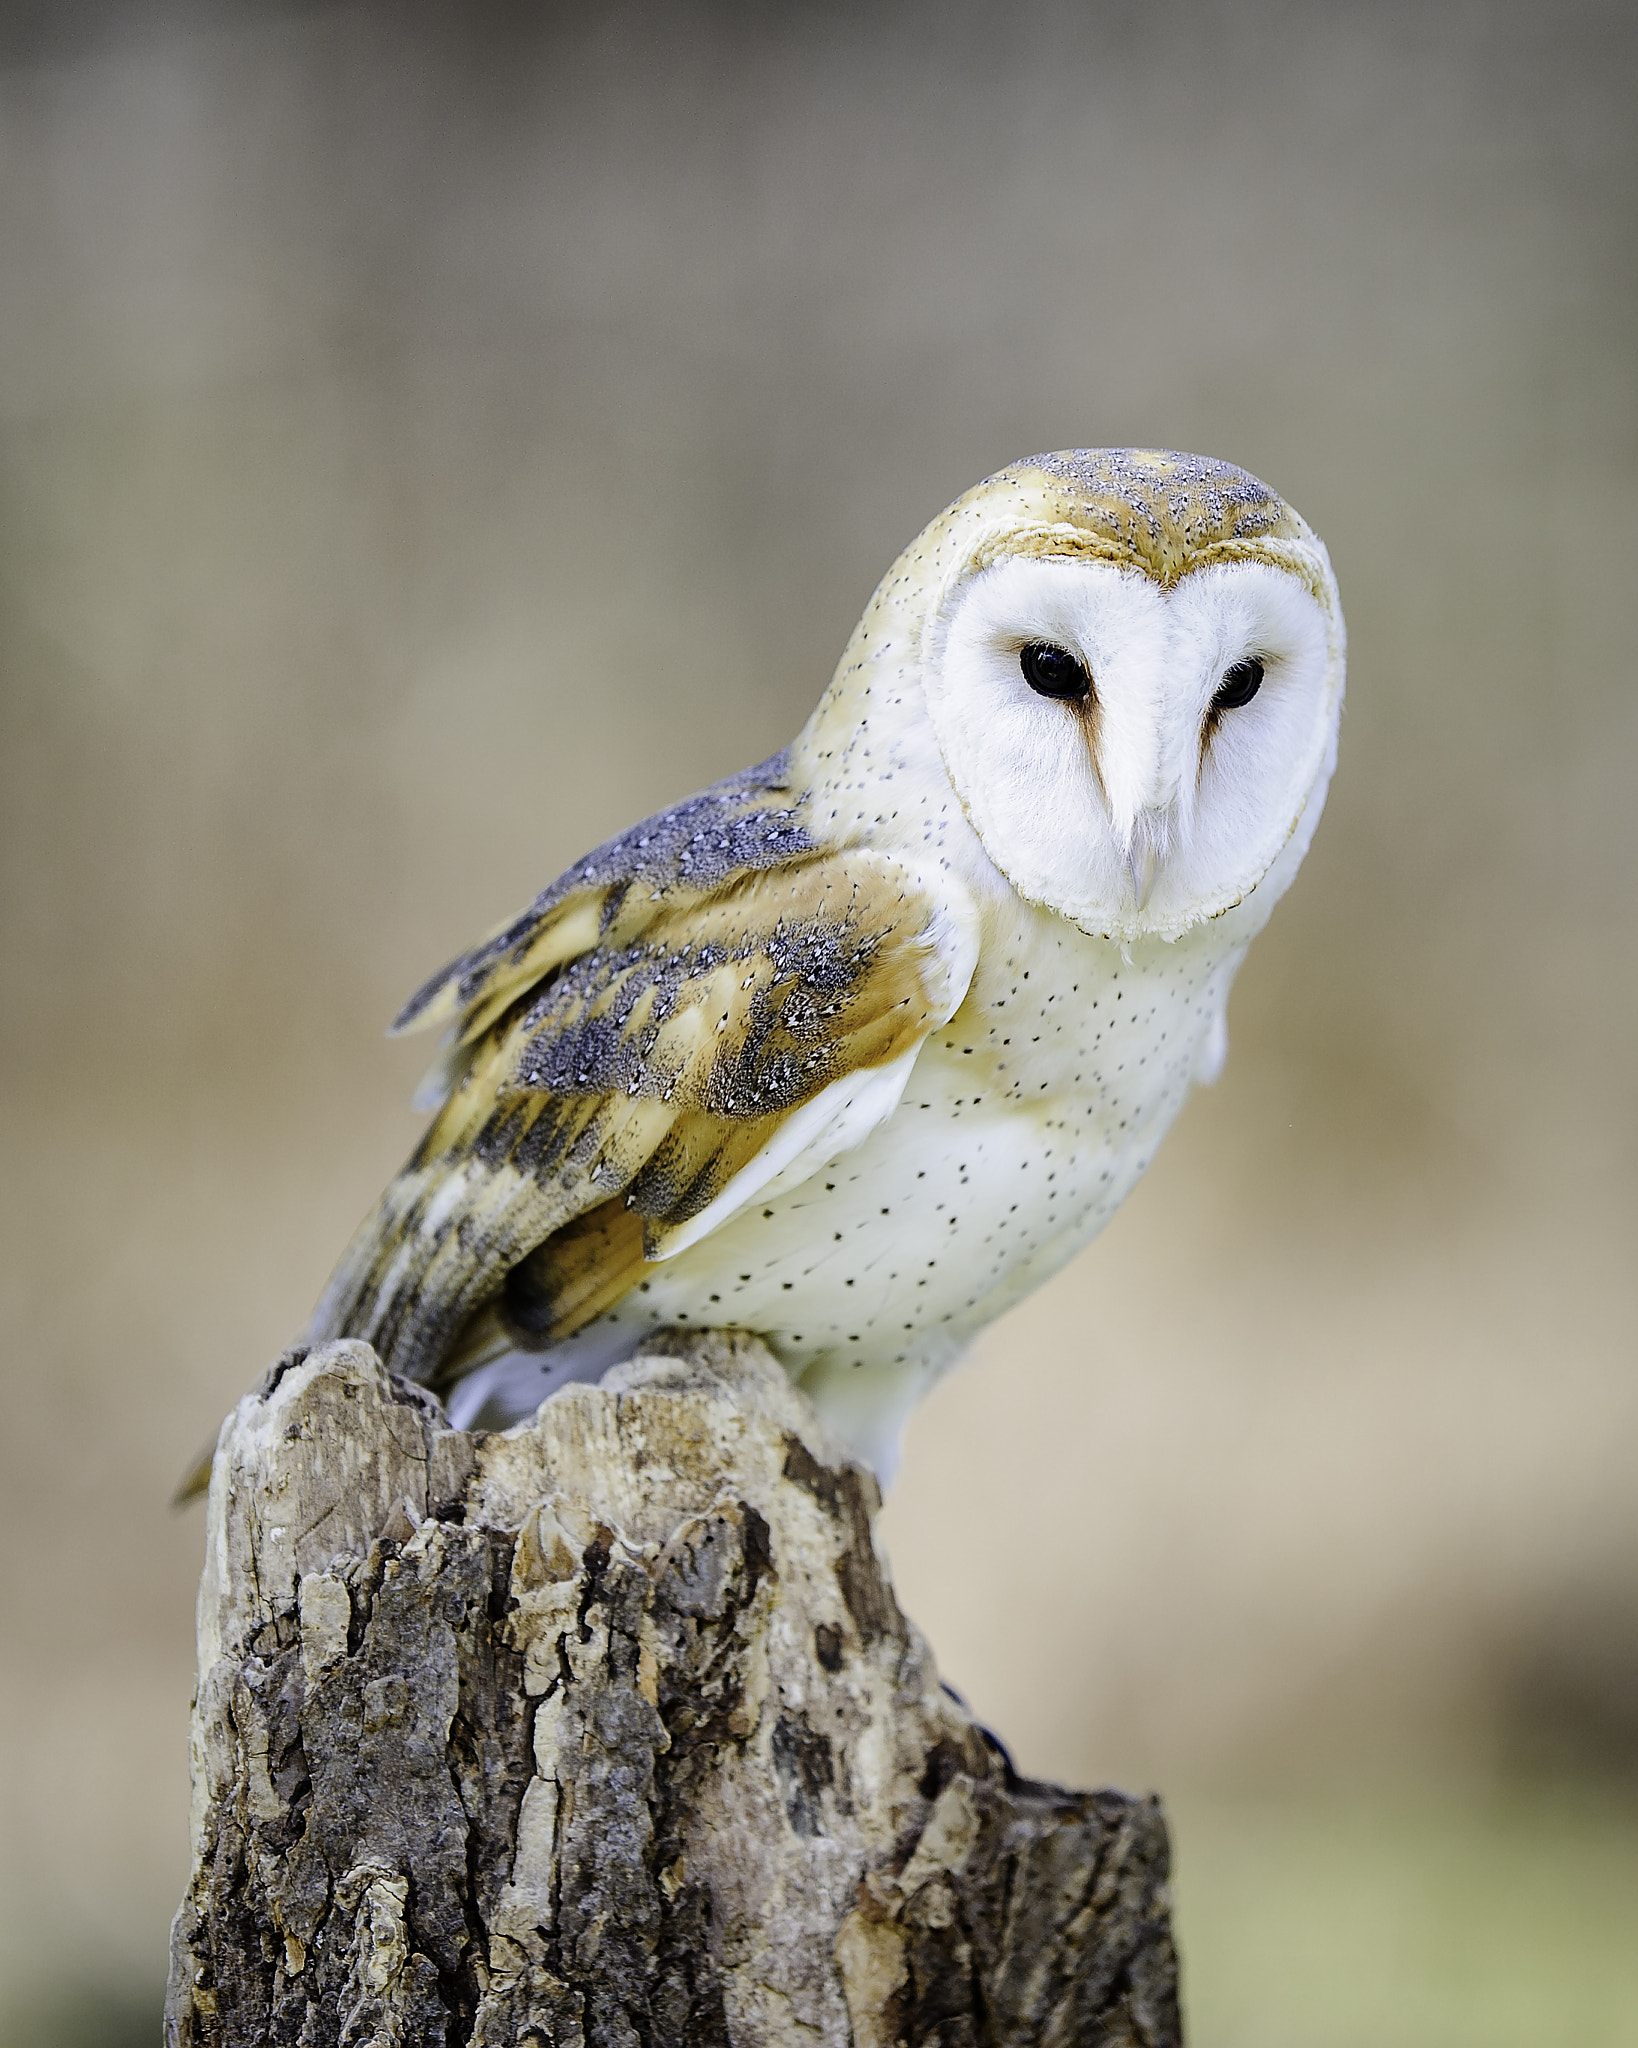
309, 793, 977, 1382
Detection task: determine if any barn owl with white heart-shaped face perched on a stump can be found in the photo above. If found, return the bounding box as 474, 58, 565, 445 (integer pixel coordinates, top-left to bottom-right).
309, 449, 1343, 1479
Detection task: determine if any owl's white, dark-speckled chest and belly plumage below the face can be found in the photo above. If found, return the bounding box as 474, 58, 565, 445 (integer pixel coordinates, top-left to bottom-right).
457, 903, 1243, 1475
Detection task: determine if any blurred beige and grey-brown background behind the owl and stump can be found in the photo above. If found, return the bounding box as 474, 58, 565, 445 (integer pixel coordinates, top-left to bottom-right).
0, 0, 1638, 2048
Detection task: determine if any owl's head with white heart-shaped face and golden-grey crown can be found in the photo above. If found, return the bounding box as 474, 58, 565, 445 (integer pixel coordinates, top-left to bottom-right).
909, 449, 1343, 942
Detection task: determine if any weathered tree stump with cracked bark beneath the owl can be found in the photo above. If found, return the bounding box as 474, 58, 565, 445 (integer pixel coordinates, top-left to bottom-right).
166, 1335, 1179, 2048
